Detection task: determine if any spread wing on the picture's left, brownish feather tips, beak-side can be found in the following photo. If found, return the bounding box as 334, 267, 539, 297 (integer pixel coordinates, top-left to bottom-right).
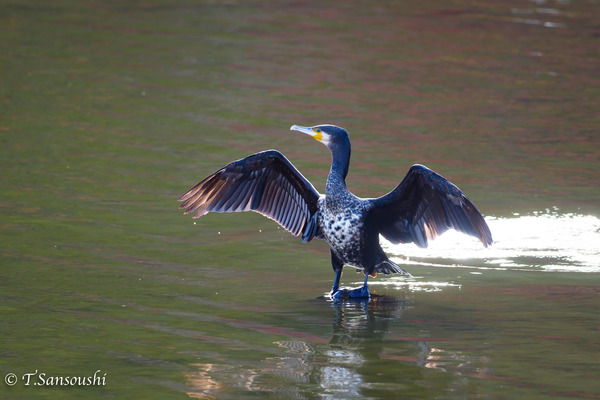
179, 150, 320, 242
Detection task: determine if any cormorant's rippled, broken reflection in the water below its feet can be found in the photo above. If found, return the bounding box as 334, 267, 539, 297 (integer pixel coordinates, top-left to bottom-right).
185, 291, 502, 399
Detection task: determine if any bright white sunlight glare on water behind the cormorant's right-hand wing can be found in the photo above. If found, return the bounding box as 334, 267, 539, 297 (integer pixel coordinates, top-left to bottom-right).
381, 210, 600, 272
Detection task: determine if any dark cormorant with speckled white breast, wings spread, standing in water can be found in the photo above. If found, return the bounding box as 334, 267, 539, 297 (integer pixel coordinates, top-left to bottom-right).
179, 125, 492, 299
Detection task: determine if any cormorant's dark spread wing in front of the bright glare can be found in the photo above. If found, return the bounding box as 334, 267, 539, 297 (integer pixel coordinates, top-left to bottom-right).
372, 165, 492, 247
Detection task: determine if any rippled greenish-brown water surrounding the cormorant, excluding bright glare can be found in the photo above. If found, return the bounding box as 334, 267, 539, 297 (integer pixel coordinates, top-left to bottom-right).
0, 0, 600, 399
